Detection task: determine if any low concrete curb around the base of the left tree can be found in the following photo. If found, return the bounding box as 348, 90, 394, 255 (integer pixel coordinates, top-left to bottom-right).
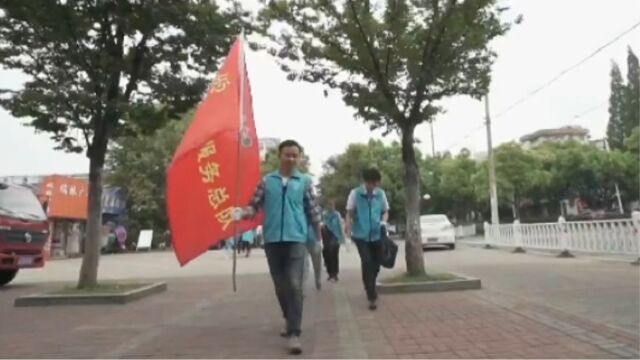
13, 282, 167, 307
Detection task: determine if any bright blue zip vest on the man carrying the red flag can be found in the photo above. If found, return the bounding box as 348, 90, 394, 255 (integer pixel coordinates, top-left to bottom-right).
263, 171, 311, 243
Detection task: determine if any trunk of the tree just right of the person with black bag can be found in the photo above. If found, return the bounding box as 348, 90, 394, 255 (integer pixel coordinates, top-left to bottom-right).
402, 125, 425, 276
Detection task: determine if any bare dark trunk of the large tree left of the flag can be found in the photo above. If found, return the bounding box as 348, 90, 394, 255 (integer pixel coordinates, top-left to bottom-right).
78, 131, 108, 289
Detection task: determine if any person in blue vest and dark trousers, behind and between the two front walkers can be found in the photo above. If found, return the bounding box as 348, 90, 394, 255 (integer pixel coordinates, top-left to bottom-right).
322, 200, 345, 282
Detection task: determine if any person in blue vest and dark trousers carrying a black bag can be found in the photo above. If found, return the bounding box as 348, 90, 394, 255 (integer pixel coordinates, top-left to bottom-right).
346, 168, 389, 310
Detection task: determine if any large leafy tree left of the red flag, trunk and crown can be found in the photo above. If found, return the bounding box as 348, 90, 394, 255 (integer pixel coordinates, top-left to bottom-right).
0, 0, 248, 288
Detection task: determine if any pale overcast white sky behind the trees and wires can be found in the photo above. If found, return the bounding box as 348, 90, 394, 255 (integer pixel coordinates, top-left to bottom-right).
0, 0, 640, 176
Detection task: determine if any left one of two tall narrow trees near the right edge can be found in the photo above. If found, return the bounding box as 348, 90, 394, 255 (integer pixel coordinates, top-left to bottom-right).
607, 62, 625, 149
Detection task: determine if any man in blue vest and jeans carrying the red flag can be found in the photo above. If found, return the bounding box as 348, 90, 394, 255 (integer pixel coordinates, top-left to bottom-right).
241, 140, 322, 354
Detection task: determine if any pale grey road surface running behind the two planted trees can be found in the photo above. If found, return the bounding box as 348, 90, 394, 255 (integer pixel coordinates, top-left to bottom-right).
14, 240, 640, 333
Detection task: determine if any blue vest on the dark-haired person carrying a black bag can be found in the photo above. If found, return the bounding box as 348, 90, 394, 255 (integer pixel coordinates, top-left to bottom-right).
351, 186, 385, 241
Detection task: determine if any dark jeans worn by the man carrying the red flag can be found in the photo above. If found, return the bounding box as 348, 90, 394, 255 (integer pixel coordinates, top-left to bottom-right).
264, 242, 307, 336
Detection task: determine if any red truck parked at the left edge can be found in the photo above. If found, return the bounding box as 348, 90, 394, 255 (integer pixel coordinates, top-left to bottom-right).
0, 183, 49, 286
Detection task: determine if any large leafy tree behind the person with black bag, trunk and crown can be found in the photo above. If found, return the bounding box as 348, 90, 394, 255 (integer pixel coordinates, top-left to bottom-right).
262, 0, 509, 275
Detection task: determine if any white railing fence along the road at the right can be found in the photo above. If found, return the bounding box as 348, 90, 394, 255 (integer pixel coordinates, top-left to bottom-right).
484, 212, 640, 257
